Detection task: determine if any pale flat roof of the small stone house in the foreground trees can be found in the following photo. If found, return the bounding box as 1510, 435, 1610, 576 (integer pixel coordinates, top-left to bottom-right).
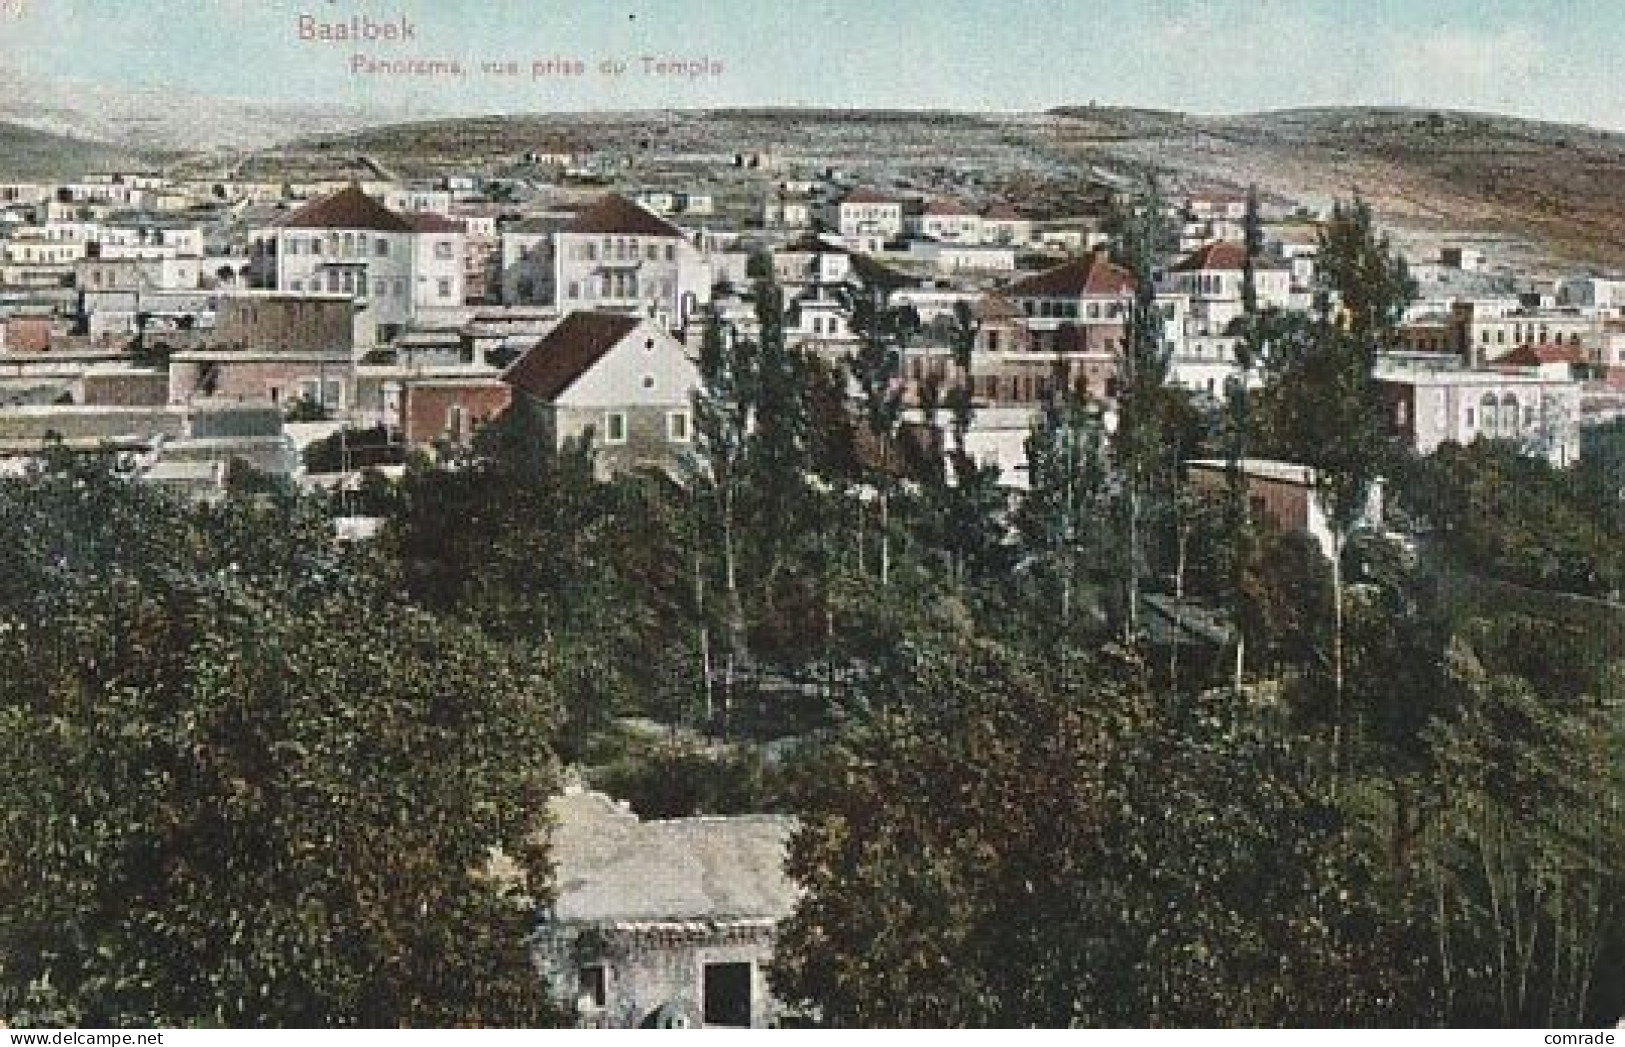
549, 790, 796, 922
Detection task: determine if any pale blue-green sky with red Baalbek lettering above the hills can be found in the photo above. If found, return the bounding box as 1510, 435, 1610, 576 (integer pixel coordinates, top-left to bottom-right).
0, 0, 1625, 130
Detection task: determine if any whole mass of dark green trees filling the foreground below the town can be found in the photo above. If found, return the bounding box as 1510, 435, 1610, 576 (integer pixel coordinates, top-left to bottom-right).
0, 191, 1625, 1026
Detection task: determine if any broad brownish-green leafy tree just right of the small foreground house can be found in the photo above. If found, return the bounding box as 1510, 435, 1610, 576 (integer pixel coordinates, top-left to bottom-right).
770, 642, 1417, 1027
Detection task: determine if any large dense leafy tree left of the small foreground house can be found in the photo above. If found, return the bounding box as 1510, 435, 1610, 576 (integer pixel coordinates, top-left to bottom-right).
0, 475, 556, 1026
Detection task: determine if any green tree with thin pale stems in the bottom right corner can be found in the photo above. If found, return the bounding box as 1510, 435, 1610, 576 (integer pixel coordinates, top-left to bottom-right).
1419, 645, 1625, 1027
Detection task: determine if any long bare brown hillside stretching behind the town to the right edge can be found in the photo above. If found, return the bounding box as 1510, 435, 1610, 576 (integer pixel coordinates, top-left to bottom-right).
237, 106, 1625, 270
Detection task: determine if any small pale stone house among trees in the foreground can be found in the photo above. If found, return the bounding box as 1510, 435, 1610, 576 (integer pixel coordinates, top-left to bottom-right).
535, 789, 796, 1027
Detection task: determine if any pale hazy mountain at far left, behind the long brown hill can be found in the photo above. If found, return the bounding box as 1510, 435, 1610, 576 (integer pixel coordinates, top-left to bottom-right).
0, 65, 390, 153
